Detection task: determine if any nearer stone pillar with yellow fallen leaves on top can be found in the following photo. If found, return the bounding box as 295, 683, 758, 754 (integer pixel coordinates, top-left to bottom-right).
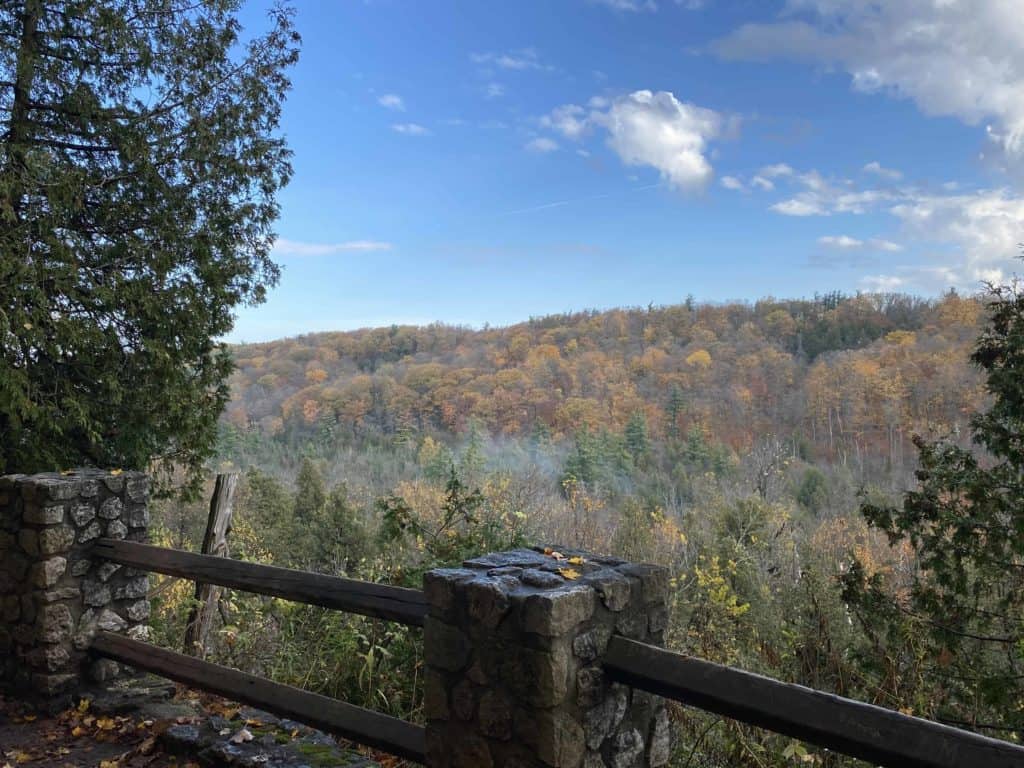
424, 550, 671, 768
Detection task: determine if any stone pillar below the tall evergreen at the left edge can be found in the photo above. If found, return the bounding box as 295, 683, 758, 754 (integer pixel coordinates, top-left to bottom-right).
0, 469, 150, 710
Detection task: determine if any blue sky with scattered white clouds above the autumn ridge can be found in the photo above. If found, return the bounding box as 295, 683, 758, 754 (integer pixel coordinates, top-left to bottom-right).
230, 0, 1024, 341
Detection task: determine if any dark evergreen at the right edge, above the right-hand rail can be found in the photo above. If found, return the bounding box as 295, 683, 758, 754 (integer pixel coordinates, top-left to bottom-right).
844, 270, 1024, 735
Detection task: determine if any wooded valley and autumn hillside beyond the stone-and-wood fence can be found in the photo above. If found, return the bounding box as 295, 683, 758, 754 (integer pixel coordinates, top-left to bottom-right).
142, 286, 1022, 768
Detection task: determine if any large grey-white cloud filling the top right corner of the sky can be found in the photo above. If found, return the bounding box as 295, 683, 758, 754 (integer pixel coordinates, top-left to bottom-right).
714, 0, 1024, 156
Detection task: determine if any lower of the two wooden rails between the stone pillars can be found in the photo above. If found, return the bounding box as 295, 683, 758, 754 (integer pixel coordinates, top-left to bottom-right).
92, 632, 426, 763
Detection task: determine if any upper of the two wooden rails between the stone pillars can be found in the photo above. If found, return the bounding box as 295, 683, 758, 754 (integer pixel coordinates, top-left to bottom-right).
93, 539, 427, 627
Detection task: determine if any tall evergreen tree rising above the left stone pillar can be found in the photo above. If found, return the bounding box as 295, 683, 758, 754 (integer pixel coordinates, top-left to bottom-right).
0, 0, 298, 495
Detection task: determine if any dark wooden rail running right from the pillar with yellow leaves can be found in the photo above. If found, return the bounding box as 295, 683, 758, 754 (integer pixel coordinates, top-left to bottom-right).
604, 637, 1024, 768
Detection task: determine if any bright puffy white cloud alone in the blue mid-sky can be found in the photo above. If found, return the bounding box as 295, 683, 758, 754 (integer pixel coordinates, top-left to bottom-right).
590, 90, 723, 190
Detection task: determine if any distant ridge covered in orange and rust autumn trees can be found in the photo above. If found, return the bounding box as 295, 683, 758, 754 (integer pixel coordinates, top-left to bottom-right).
225, 293, 983, 465
